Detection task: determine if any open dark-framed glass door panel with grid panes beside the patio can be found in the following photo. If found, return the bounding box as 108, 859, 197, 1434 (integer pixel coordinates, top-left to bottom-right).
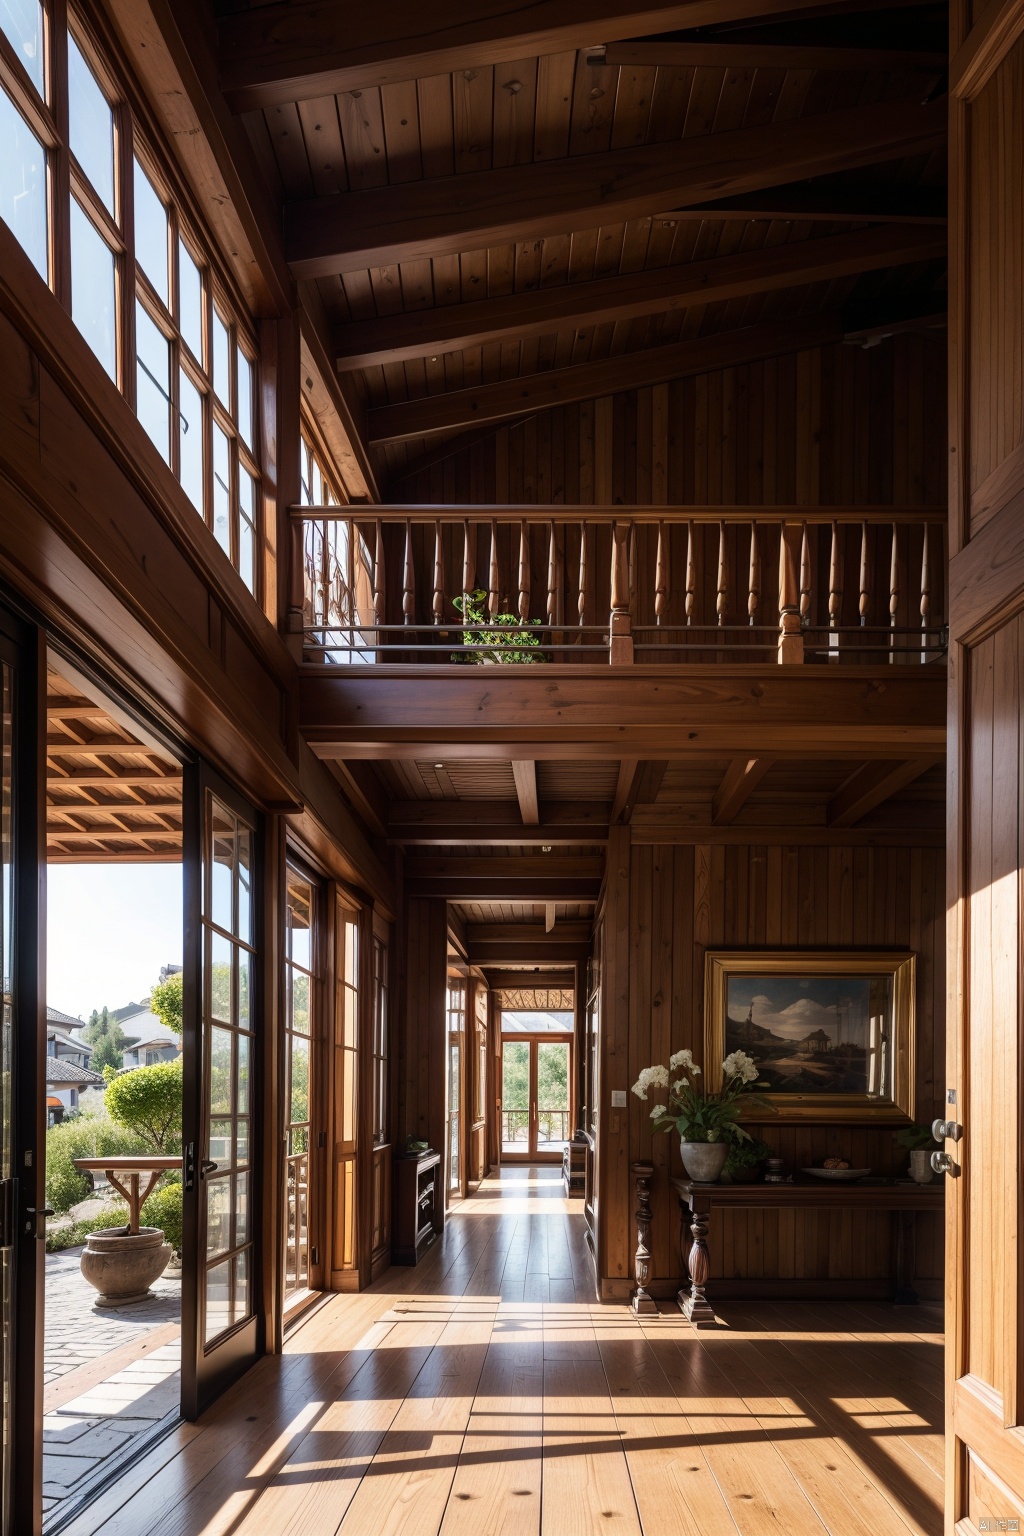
181, 765, 261, 1418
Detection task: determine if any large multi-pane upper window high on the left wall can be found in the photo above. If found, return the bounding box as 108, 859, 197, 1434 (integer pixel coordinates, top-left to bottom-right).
0, 10, 261, 598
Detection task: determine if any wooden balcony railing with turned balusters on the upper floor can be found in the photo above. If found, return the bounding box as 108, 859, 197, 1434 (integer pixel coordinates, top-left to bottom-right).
289, 505, 946, 665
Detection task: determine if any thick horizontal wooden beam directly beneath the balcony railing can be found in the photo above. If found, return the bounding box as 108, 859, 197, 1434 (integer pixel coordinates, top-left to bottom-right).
299, 664, 946, 760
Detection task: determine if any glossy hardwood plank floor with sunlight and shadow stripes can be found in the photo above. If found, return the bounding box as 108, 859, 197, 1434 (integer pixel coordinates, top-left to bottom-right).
62, 1167, 943, 1536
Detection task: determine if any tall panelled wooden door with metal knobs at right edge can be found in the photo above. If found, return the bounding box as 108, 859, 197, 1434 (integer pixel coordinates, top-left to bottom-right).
936, 9, 1024, 1536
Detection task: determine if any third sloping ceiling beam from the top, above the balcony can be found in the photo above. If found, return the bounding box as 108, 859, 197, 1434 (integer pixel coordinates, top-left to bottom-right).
335, 224, 946, 369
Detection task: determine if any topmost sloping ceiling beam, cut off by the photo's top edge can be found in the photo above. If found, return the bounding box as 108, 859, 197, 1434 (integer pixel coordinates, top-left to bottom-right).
220, 0, 921, 112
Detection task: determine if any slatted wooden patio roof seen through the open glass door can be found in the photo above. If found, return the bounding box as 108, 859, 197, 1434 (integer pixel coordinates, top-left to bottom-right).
46, 667, 181, 863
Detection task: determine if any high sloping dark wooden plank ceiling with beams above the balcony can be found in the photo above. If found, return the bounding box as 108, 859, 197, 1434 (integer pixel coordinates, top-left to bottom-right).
220, 0, 946, 485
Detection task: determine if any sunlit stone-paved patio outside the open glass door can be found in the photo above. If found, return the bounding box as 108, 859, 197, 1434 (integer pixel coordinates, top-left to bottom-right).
43, 1249, 181, 1524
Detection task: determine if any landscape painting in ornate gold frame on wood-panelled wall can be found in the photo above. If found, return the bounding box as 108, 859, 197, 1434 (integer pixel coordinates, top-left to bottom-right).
705, 949, 915, 1123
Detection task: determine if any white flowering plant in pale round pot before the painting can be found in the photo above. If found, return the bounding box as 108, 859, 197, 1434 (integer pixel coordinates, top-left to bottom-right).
633, 1051, 771, 1184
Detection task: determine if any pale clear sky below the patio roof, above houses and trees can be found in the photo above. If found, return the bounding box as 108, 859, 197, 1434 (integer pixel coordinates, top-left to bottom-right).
46, 863, 181, 1018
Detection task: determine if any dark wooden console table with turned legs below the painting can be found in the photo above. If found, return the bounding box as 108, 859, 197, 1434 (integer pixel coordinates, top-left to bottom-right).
671, 1175, 946, 1322
